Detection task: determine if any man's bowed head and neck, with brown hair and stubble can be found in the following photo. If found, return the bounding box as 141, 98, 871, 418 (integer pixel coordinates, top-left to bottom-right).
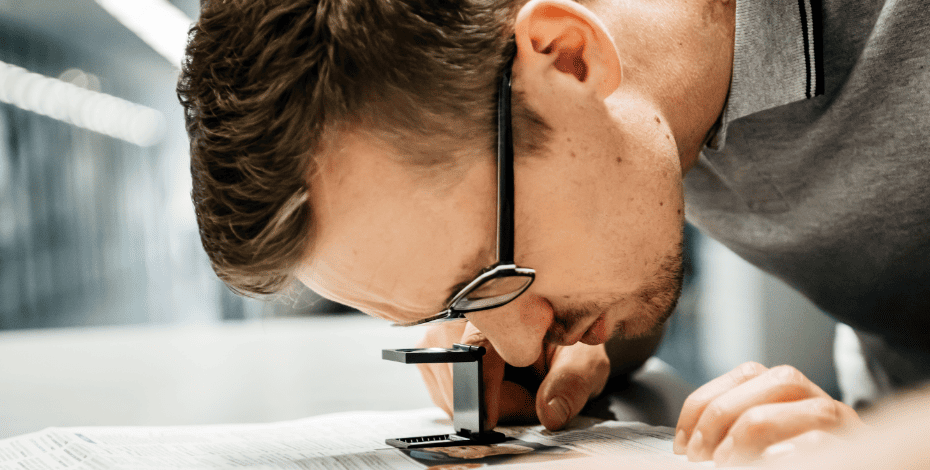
181, 0, 732, 365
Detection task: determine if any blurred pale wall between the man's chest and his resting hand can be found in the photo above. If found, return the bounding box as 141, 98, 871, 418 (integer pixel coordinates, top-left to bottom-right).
675, 231, 839, 397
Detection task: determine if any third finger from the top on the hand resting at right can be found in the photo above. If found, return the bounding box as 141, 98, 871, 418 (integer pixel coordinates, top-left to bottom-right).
714, 397, 858, 466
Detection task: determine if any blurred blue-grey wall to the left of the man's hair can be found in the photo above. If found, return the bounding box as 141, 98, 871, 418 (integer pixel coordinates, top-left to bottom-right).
0, 0, 352, 330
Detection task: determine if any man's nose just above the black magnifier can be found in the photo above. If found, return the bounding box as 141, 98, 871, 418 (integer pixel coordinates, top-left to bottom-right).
466, 293, 553, 367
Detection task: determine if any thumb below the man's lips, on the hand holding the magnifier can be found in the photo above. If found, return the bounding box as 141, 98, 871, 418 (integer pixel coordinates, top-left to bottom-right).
536, 343, 610, 430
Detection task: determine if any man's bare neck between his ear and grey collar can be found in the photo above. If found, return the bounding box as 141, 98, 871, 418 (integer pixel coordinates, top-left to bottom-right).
592, 0, 736, 172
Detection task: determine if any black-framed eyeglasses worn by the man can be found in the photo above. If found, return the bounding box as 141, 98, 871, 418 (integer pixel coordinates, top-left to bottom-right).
394, 61, 536, 326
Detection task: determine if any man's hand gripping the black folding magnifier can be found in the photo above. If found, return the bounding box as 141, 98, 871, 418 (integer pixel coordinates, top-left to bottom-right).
418, 323, 610, 430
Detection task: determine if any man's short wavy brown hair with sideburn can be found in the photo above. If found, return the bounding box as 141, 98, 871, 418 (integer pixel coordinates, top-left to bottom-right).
177, 0, 546, 295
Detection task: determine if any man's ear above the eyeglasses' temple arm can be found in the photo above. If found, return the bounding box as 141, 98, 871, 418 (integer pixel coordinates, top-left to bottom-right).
514, 0, 621, 99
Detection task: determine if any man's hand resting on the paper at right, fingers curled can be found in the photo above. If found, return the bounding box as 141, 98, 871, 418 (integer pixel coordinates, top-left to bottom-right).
674, 362, 864, 466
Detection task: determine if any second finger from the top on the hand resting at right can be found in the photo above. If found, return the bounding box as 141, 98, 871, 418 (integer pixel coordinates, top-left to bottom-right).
688, 366, 830, 461
